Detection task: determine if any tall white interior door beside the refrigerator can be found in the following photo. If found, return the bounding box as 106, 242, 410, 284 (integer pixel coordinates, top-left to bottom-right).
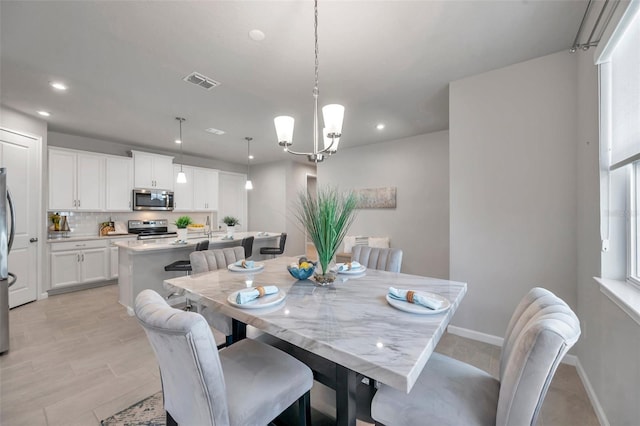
0, 129, 43, 308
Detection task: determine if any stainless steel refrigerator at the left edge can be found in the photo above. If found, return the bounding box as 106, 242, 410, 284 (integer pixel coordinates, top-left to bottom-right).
0, 167, 17, 354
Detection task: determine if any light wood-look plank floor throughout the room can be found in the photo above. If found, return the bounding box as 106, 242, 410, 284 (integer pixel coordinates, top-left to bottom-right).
0, 286, 598, 426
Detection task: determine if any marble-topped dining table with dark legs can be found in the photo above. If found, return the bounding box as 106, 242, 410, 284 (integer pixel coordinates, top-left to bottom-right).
164, 256, 467, 426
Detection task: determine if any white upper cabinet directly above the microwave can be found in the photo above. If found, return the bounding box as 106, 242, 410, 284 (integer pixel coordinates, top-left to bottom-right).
131, 151, 174, 191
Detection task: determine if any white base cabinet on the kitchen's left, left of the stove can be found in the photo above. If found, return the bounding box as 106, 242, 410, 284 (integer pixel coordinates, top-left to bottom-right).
50, 240, 110, 289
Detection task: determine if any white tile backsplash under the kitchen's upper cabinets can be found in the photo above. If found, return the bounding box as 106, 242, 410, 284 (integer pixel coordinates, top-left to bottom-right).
47, 211, 224, 236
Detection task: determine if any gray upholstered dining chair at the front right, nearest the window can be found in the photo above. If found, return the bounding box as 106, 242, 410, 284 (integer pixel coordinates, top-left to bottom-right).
371, 287, 580, 426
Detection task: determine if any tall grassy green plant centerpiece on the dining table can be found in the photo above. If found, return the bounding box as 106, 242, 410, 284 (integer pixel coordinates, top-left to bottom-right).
295, 187, 358, 285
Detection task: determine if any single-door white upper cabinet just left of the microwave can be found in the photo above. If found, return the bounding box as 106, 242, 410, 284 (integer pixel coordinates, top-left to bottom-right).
105, 156, 133, 211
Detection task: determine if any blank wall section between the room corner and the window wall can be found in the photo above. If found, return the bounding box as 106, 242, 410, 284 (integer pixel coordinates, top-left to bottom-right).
450, 52, 577, 336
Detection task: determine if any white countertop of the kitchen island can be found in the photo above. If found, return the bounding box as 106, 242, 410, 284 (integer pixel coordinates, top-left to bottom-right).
114, 232, 280, 253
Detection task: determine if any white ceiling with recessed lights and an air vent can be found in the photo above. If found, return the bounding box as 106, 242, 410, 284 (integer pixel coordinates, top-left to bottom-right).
0, 0, 586, 164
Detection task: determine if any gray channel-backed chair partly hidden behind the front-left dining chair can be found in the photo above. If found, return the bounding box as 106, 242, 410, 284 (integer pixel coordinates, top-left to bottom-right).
189, 246, 245, 347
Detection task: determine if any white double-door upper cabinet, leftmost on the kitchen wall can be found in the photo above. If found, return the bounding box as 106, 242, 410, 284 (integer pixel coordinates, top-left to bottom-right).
49, 148, 106, 211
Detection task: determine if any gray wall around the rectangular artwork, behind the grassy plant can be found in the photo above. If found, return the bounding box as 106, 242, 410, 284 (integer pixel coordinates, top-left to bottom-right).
318, 131, 449, 278
